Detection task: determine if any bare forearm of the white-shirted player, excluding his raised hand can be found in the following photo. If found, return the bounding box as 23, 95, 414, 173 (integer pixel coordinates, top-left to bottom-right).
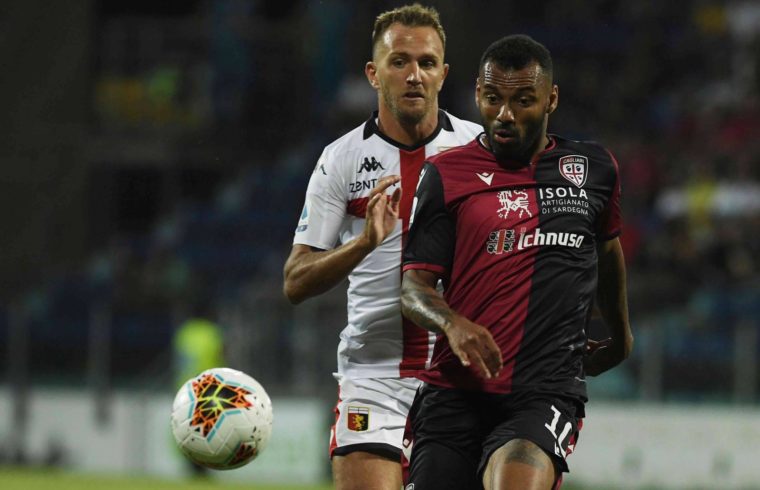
283, 238, 372, 304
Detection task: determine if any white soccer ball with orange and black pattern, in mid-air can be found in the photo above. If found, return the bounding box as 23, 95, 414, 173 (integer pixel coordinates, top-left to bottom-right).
171, 368, 272, 470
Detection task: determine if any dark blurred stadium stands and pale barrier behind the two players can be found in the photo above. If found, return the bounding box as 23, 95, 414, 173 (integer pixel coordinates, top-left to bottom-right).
0, 0, 760, 489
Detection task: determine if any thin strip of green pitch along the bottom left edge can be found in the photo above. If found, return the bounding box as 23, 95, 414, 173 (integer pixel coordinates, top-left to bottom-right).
0, 467, 332, 490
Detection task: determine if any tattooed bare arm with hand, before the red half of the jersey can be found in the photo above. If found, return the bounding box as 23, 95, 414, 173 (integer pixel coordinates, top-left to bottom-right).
401, 270, 502, 379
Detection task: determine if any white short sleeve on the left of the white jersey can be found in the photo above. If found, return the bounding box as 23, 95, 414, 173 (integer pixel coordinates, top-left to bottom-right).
293, 151, 347, 250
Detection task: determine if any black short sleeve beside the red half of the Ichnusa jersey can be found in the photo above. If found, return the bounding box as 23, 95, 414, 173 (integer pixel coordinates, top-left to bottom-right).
404, 162, 456, 276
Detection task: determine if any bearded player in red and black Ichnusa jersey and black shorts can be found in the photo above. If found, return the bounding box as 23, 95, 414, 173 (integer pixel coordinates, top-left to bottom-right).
402, 35, 633, 490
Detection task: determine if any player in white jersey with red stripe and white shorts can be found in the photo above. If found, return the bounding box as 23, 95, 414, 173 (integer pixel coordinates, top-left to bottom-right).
284, 4, 482, 490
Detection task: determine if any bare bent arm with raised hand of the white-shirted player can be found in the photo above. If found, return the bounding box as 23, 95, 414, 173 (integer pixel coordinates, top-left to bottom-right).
283, 175, 401, 304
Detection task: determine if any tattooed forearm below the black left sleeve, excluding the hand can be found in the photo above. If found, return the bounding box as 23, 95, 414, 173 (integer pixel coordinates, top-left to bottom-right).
401, 275, 456, 333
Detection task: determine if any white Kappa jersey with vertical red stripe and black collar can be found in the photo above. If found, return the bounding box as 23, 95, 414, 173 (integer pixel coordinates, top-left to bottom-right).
293, 110, 482, 378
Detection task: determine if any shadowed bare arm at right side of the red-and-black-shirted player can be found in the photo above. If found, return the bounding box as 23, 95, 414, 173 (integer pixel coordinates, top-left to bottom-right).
584, 238, 633, 376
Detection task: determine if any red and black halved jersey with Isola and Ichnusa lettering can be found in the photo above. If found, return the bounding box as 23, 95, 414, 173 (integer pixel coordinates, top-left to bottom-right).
404, 135, 620, 399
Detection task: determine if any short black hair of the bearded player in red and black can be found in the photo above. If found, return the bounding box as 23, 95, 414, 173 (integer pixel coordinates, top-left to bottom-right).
479, 34, 553, 80
